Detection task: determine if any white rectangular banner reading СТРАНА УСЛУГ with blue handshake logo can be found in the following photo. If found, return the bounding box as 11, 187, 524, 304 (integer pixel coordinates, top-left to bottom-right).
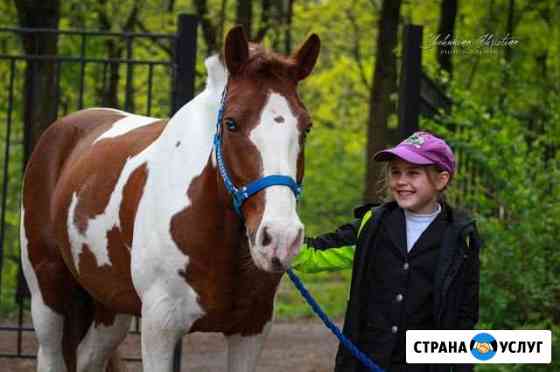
406, 330, 552, 364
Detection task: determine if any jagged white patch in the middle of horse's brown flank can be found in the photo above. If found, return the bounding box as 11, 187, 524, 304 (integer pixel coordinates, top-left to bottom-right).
67, 154, 150, 272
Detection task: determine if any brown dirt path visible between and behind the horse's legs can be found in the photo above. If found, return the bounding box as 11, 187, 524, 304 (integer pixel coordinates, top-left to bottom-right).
0, 319, 337, 372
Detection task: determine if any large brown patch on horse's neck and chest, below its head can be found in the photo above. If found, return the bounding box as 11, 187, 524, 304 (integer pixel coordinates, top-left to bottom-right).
170, 163, 281, 335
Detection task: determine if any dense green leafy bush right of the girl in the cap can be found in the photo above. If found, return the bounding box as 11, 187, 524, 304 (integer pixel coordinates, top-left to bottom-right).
423, 78, 560, 329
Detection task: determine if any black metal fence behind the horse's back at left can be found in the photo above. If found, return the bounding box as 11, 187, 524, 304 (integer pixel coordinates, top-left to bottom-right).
0, 14, 197, 370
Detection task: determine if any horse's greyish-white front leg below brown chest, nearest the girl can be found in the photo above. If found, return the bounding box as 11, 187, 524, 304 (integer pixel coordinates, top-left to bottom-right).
226, 321, 272, 372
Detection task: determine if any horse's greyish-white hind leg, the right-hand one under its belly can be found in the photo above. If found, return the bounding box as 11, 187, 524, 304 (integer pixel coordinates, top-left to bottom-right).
78, 304, 132, 372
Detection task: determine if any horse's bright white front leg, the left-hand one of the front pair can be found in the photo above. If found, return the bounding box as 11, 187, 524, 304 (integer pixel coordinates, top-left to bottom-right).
142, 290, 200, 372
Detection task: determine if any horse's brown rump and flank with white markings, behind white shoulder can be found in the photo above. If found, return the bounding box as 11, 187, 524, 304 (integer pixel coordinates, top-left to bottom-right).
22, 109, 165, 312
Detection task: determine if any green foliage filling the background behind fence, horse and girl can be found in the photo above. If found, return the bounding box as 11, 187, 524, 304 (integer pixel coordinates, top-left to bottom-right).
0, 7, 560, 371
